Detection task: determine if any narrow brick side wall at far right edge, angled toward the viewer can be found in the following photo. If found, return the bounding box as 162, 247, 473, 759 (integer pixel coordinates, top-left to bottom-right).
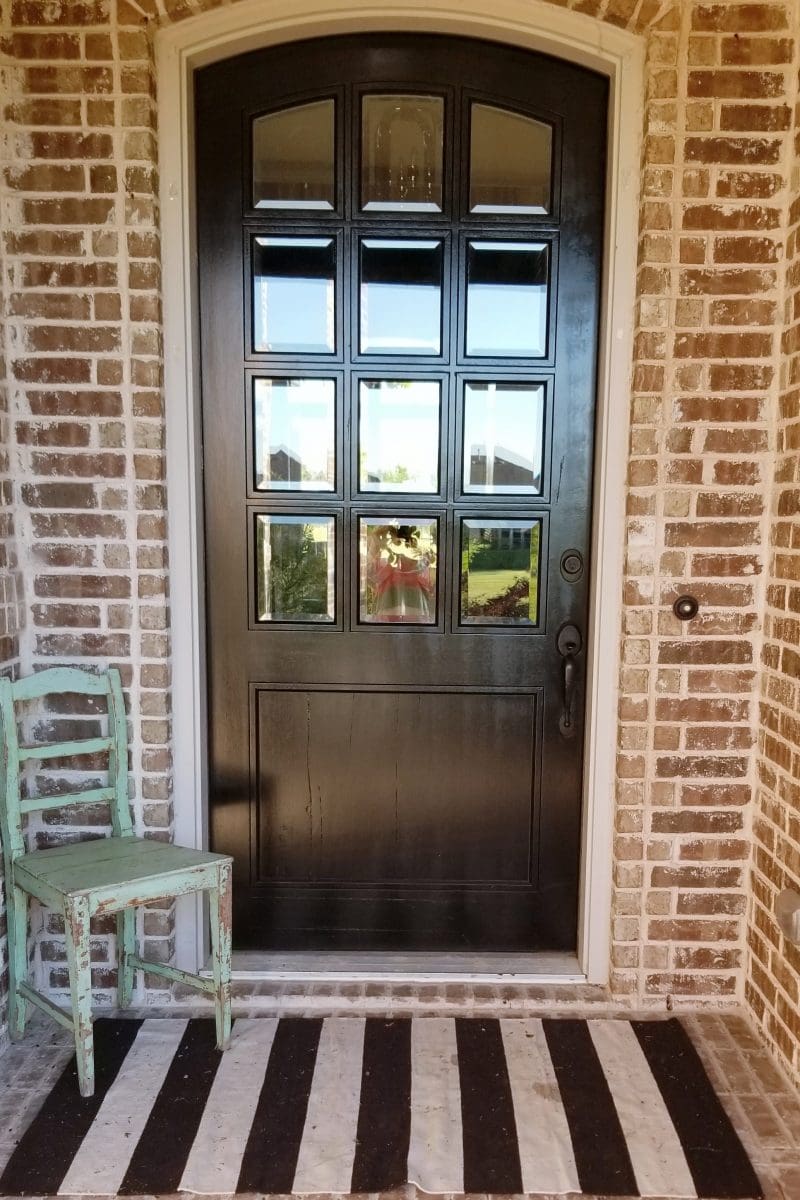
746, 10, 800, 1078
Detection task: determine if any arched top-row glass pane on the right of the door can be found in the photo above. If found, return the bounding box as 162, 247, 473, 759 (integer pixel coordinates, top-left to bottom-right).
469, 104, 553, 212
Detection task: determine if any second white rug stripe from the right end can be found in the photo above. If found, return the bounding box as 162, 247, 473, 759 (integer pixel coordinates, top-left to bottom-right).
500, 1018, 581, 1193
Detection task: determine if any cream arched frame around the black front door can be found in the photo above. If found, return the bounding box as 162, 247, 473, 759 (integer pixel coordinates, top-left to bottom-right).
156, 0, 645, 984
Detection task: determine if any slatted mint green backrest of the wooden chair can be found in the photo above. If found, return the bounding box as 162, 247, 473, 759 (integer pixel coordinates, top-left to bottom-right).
0, 667, 133, 869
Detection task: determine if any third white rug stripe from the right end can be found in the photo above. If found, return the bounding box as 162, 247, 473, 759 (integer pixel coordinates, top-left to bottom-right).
408, 1016, 464, 1193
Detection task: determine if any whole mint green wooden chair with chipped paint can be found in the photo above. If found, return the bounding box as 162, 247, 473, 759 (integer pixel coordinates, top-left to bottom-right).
0, 667, 231, 1096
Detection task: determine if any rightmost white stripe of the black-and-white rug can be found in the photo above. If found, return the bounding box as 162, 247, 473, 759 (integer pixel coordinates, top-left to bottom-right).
589, 1020, 697, 1198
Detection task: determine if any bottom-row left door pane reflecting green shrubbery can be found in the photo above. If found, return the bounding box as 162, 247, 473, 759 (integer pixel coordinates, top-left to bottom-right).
255, 514, 336, 622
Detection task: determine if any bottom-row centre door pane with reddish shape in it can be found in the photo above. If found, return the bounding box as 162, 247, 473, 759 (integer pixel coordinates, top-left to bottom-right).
359, 516, 439, 625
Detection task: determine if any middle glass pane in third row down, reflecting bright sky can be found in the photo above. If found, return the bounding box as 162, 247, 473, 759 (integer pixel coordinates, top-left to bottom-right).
359, 379, 441, 492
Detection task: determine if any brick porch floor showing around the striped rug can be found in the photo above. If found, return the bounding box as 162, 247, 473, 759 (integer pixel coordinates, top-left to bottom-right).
0, 996, 800, 1200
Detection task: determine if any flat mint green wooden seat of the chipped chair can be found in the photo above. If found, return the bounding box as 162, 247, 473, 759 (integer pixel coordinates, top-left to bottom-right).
13, 838, 230, 901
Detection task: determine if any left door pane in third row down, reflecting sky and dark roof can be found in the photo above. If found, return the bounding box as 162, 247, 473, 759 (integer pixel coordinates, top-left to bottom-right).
253, 379, 336, 492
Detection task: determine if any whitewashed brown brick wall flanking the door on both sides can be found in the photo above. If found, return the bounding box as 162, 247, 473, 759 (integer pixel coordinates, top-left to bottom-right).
2, 0, 798, 1070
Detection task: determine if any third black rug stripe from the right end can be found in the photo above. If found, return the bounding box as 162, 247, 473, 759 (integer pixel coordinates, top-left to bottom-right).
456, 1018, 522, 1193
